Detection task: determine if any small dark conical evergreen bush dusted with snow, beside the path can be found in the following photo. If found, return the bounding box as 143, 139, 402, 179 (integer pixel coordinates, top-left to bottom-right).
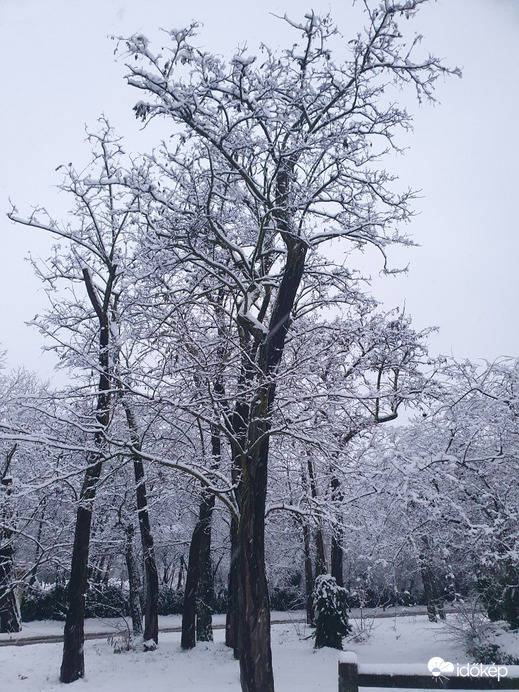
313, 574, 351, 649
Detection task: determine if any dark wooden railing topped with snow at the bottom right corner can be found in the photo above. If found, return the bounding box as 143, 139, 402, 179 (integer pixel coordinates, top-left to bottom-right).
339, 652, 519, 692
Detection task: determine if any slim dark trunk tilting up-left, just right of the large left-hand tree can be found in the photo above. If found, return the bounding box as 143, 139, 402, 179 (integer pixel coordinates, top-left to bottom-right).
124, 402, 159, 649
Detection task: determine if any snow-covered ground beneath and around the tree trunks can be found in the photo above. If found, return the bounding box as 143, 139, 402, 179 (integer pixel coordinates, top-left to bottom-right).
0, 613, 519, 692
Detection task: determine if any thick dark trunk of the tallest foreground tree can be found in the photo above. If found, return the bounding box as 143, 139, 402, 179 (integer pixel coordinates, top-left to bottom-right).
234, 234, 306, 692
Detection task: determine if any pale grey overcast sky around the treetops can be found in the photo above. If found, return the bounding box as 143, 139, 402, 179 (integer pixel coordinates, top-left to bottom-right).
0, 0, 519, 376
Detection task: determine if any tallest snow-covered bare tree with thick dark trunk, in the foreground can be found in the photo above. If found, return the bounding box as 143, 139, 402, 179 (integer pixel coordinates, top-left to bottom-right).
120, 0, 458, 692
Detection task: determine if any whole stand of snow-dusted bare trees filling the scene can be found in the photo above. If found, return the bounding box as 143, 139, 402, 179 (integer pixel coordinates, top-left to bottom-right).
0, 0, 519, 692
